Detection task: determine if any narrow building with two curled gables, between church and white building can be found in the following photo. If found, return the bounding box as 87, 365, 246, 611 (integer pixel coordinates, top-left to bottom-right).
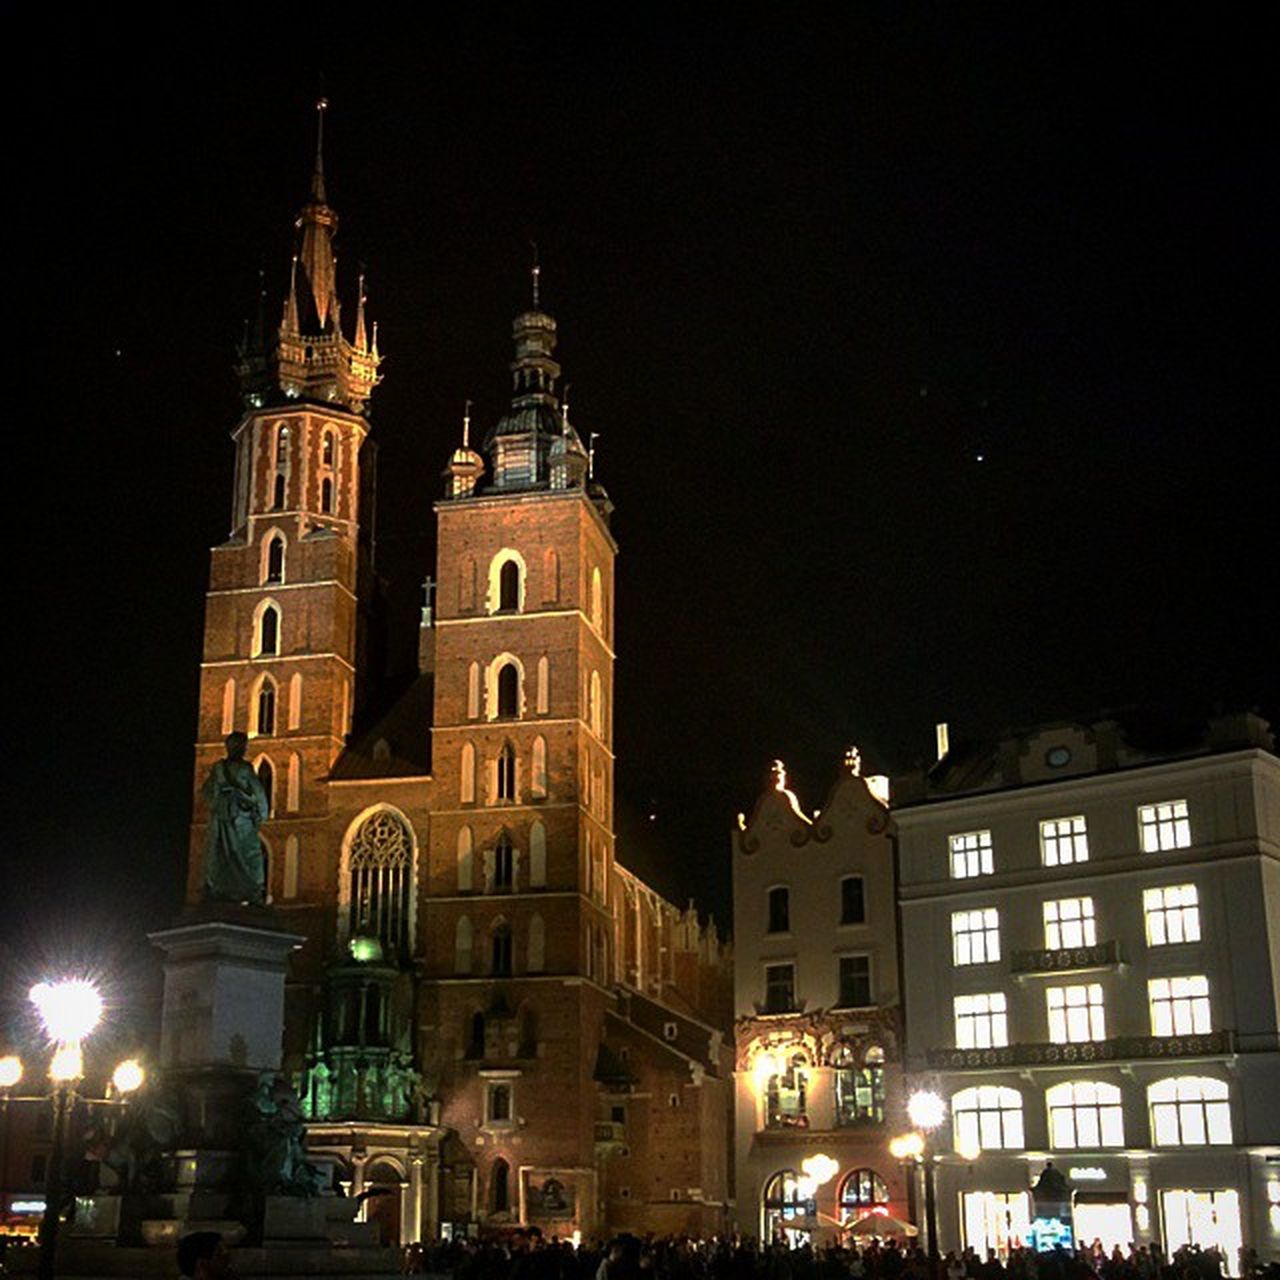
733, 751, 913, 1243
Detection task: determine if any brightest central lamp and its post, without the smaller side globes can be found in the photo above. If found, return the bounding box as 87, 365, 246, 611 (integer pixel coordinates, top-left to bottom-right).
31, 978, 102, 1280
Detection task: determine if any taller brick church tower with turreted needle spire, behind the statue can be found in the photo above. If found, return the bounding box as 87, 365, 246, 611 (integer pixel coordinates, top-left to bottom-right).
189, 100, 380, 897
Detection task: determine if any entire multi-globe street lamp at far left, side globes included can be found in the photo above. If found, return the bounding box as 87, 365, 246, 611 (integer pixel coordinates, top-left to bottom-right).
0, 978, 146, 1280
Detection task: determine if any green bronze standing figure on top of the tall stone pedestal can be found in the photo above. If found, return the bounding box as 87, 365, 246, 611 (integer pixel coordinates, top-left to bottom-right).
202, 730, 270, 902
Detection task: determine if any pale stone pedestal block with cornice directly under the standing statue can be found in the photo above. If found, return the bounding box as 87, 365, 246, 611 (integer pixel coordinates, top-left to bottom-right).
148, 904, 306, 1075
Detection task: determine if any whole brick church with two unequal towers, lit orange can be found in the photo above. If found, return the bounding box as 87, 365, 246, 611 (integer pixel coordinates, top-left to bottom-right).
188, 109, 733, 1243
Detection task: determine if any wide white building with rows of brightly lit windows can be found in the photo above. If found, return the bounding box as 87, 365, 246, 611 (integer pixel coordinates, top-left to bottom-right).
893, 716, 1280, 1274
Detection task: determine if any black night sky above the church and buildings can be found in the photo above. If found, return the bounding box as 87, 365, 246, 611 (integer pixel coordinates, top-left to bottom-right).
0, 5, 1280, 1018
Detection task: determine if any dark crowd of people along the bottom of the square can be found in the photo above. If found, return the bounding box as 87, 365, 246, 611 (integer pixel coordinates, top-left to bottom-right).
404, 1230, 1280, 1280
